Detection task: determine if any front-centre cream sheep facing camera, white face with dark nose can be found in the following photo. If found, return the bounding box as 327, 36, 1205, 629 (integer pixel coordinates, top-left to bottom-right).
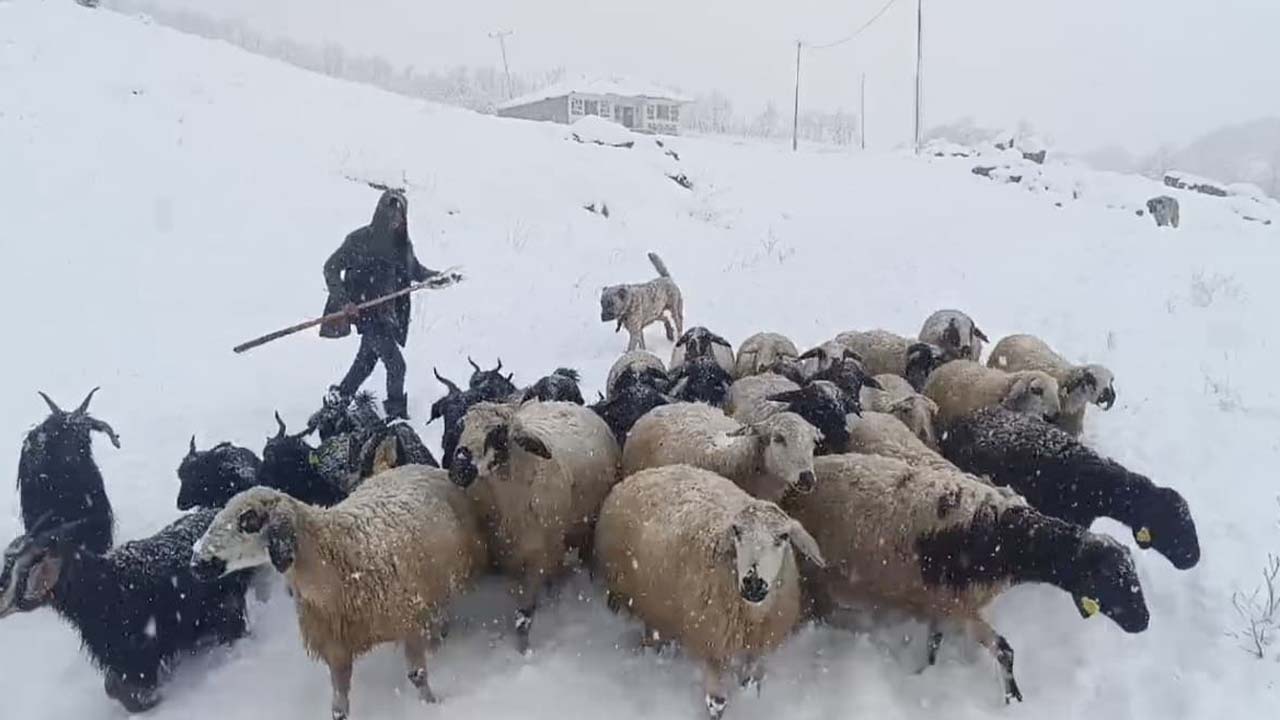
595, 465, 823, 720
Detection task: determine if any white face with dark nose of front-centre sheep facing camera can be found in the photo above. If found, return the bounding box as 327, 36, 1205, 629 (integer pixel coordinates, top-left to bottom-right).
730, 503, 823, 605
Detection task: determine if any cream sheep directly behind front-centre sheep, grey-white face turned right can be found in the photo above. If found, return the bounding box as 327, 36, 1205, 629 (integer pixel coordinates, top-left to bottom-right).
622, 402, 822, 501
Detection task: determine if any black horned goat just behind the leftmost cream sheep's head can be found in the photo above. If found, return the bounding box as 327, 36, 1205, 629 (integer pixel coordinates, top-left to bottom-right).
257, 413, 355, 506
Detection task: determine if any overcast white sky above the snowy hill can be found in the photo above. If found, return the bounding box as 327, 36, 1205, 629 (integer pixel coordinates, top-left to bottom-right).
117, 0, 1280, 151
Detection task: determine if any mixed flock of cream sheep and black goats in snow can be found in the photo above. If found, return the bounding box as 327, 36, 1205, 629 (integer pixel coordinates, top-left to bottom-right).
0, 299, 1199, 720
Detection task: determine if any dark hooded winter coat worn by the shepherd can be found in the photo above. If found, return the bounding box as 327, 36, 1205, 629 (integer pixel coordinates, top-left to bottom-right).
320, 190, 436, 346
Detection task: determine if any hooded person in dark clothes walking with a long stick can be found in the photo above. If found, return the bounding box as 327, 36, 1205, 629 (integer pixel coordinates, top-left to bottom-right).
320, 190, 439, 419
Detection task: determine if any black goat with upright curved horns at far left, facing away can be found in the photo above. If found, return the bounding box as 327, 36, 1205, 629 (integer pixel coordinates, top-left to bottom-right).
18, 388, 120, 552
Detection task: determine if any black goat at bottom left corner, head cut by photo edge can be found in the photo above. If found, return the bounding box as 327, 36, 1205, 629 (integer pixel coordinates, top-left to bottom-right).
0, 510, 252, 712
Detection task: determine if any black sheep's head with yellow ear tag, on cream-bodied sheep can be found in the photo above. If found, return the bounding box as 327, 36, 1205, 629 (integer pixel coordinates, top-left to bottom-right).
1071, 533, 1151, 633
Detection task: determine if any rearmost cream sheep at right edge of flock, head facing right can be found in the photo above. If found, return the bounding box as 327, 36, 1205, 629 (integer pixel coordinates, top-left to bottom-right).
987, 334, 1116, 436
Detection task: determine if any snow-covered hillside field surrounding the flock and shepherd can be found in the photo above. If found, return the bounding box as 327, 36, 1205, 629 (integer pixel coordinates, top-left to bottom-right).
0, 0, 1280, 720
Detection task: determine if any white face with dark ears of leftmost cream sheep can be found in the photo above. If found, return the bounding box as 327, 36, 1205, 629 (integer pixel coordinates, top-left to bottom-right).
191, 487, 293, 580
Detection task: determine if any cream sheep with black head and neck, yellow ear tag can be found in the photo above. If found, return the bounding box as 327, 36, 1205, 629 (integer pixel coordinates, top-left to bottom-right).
783, 455, 1149, 702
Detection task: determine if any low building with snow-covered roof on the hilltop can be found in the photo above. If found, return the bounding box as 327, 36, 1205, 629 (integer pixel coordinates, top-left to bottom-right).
498, 79, 690, 135
